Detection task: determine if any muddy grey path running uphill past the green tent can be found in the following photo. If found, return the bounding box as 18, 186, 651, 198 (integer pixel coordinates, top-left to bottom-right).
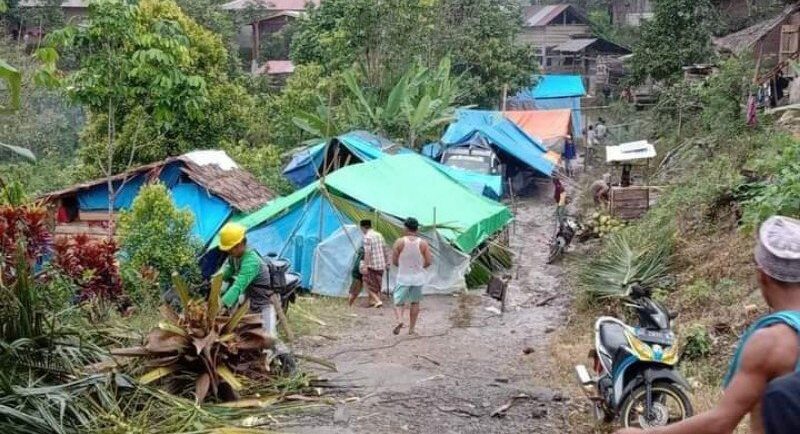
282, 191, 570, 434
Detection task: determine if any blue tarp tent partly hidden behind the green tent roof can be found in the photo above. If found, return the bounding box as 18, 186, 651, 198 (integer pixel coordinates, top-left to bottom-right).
283, 131, 503, 200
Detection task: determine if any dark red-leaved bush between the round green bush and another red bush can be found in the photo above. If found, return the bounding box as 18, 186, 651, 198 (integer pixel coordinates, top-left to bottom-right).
53, 234, 122, 301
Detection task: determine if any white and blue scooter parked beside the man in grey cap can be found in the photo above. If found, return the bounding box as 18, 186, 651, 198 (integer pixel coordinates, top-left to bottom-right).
575, 284, 693, 428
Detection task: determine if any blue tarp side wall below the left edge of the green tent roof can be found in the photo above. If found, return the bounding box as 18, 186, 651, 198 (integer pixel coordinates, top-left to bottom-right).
247, 190, 353, 288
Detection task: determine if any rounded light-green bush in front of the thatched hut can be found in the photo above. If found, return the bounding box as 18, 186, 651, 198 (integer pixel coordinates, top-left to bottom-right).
117, 183, 201, 300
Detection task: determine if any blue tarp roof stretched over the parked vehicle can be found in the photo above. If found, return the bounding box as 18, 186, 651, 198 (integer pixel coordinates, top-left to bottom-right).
441, 110, 555, 176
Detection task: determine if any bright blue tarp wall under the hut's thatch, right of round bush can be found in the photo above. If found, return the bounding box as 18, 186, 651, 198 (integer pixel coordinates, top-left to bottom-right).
172, 183, 231, 245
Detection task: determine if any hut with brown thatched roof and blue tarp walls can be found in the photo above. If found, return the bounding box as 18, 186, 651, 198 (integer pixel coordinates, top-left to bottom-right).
43, 150, 273, 245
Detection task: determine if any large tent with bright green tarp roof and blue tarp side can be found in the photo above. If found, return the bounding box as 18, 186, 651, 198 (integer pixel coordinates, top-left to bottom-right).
212, 154, 511, 291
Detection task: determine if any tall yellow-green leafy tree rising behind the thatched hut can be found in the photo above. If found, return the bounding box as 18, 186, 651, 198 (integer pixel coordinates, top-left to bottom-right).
41, 0, 252, 175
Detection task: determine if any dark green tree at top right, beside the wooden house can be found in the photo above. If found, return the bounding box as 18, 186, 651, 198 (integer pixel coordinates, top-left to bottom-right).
631, 0, 713, 83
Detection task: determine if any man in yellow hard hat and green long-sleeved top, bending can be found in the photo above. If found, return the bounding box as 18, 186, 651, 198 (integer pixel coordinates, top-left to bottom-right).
219, 223, 276, 336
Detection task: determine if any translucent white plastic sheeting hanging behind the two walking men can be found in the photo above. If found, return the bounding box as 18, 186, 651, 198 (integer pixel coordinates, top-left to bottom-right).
311, 225, 470, 297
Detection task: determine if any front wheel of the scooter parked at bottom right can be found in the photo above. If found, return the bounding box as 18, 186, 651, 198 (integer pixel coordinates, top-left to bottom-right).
619, 382, 694, 428
